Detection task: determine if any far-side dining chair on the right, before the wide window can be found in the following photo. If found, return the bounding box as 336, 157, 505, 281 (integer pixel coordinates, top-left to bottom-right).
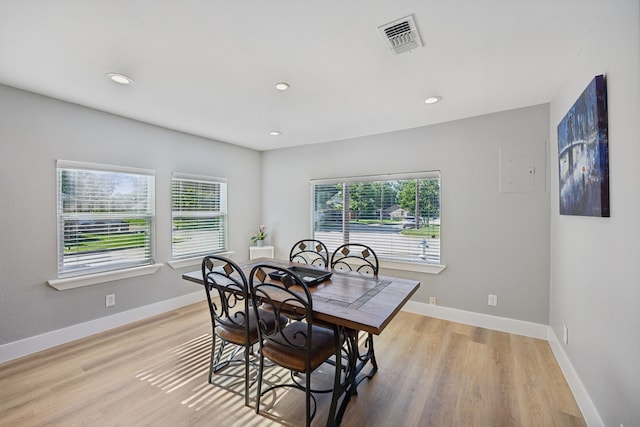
331, 243, 380, 394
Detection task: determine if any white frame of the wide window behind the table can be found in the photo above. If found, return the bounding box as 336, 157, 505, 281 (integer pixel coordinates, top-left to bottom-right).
310, 171, 446, 274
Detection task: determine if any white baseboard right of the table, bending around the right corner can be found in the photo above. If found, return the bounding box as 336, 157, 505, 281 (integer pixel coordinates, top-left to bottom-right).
403, 301, 604, 427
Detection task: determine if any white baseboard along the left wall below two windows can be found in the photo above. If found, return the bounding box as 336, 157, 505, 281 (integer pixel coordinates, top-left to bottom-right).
0, 292, 205, 363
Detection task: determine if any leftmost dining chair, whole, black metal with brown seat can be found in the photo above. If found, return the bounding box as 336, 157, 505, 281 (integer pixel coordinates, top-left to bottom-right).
202, 255, 288, 406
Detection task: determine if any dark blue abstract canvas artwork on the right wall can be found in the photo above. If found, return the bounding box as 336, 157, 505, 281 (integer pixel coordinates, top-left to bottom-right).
558, 75, 610, 217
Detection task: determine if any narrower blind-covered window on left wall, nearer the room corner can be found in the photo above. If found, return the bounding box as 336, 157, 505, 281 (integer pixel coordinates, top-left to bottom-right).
171, 173, 227, 259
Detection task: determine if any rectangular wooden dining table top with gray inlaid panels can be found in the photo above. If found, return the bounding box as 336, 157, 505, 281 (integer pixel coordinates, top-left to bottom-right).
182, 258, 420, 335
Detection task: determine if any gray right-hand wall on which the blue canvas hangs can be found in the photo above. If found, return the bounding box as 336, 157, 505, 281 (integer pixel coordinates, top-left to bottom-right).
550, 0, 640, 427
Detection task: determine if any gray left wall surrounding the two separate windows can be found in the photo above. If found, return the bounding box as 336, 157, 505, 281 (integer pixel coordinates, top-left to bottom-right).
0, 86, 261, 344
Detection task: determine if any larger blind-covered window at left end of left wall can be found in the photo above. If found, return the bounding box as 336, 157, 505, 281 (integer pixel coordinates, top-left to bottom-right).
57, 160, 155, 278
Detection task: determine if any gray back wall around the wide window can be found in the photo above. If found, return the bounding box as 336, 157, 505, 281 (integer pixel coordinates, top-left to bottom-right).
262, 105, 549, 324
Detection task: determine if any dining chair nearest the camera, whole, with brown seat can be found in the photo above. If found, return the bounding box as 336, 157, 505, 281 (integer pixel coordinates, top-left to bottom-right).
249, 264, 343, 426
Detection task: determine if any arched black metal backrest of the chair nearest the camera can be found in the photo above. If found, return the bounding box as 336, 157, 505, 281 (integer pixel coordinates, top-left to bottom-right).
249, 264, 313, 368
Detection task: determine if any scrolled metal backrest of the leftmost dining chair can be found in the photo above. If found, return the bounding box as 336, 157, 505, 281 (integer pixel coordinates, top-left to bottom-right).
202, 255, 249, 339
